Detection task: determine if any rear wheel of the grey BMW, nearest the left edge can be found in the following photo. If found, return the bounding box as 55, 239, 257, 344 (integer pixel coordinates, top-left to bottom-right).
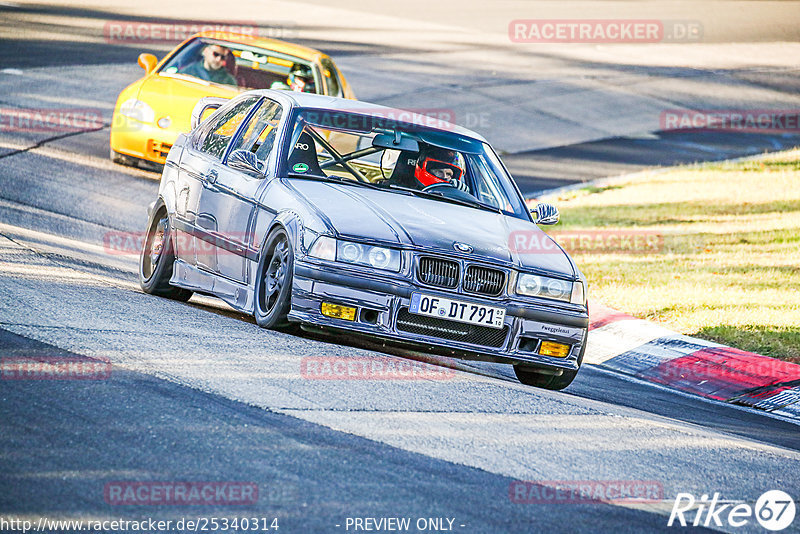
139, 206, 192, 302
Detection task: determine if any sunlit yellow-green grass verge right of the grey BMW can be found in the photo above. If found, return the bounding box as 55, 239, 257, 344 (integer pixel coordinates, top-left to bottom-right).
548, 150, 800, 363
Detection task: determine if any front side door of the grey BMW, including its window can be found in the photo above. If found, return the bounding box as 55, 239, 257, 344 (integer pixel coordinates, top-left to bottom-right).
197, 98, 282, 283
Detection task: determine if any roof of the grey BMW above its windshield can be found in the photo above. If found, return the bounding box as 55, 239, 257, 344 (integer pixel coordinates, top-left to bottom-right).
253, 89, 488, 143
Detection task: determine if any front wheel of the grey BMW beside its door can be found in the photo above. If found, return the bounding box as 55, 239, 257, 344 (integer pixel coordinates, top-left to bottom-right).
253, 228, 294, 328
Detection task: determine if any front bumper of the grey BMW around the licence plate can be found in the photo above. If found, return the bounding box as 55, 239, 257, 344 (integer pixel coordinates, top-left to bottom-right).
289, 261, 589, 369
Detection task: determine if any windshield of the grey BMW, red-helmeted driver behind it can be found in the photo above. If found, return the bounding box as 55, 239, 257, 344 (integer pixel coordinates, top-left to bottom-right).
284, 109, 529, 220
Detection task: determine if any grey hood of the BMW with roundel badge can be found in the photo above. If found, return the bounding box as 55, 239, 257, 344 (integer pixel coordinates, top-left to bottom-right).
285, 179, 575, 277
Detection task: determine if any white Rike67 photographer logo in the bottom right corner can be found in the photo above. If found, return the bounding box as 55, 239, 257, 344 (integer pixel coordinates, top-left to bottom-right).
667, 490, 797, 531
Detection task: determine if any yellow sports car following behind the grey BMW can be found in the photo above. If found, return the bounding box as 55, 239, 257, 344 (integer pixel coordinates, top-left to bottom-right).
110, 32, 355, 166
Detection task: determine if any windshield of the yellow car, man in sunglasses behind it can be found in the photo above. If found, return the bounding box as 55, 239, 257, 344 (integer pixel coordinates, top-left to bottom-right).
159, 37, 323, 93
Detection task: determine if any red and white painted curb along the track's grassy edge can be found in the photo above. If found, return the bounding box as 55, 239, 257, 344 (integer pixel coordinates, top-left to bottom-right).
584, 302, 800, 421
